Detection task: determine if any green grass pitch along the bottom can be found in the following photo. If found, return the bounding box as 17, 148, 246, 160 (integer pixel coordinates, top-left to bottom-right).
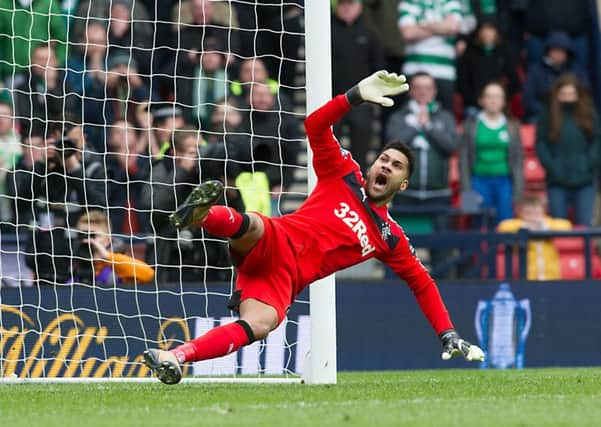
0, 368, 601, 427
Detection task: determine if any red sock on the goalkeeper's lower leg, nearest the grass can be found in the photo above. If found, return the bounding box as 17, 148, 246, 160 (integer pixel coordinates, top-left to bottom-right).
171, 321, 250, 363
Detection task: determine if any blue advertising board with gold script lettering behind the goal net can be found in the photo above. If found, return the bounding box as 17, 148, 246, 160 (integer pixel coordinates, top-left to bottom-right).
0, 284, 310, 378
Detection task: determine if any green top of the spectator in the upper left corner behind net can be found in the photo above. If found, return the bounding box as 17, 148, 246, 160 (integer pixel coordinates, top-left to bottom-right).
0, 0, 67, 87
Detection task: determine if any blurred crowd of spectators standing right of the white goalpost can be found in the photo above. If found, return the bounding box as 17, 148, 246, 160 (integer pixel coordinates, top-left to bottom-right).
342, 0, 601, 234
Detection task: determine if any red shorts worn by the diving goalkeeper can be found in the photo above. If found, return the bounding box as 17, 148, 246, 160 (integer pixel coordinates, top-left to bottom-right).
236, 213, 296, 323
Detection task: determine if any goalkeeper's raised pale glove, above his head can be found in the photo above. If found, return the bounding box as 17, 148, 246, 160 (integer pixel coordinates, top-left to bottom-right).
346, 70, 409, 107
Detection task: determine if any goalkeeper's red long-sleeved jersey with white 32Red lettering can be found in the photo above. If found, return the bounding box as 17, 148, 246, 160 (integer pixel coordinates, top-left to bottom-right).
273, 95, 453, 333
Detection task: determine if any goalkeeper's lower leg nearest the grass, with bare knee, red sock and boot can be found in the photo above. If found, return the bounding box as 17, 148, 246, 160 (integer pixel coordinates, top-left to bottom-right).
144, 299, 279, 384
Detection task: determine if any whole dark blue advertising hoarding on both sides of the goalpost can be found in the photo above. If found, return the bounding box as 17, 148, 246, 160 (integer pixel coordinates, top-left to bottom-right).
0, 281, 601, 377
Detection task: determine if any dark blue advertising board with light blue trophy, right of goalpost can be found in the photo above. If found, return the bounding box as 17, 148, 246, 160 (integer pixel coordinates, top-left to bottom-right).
337, 282, 601, 370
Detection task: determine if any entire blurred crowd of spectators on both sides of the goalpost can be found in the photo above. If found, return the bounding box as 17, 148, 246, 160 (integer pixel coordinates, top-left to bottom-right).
0, 0, 601, 280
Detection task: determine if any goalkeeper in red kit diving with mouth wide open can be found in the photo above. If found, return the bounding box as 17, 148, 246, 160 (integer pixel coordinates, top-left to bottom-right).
144, 70, 484, 384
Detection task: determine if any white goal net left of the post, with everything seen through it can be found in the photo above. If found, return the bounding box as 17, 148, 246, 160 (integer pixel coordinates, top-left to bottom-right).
0, 0, 330, 379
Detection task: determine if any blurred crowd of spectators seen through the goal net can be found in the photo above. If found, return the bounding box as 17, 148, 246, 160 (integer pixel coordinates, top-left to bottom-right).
0, 0, 303, 283
